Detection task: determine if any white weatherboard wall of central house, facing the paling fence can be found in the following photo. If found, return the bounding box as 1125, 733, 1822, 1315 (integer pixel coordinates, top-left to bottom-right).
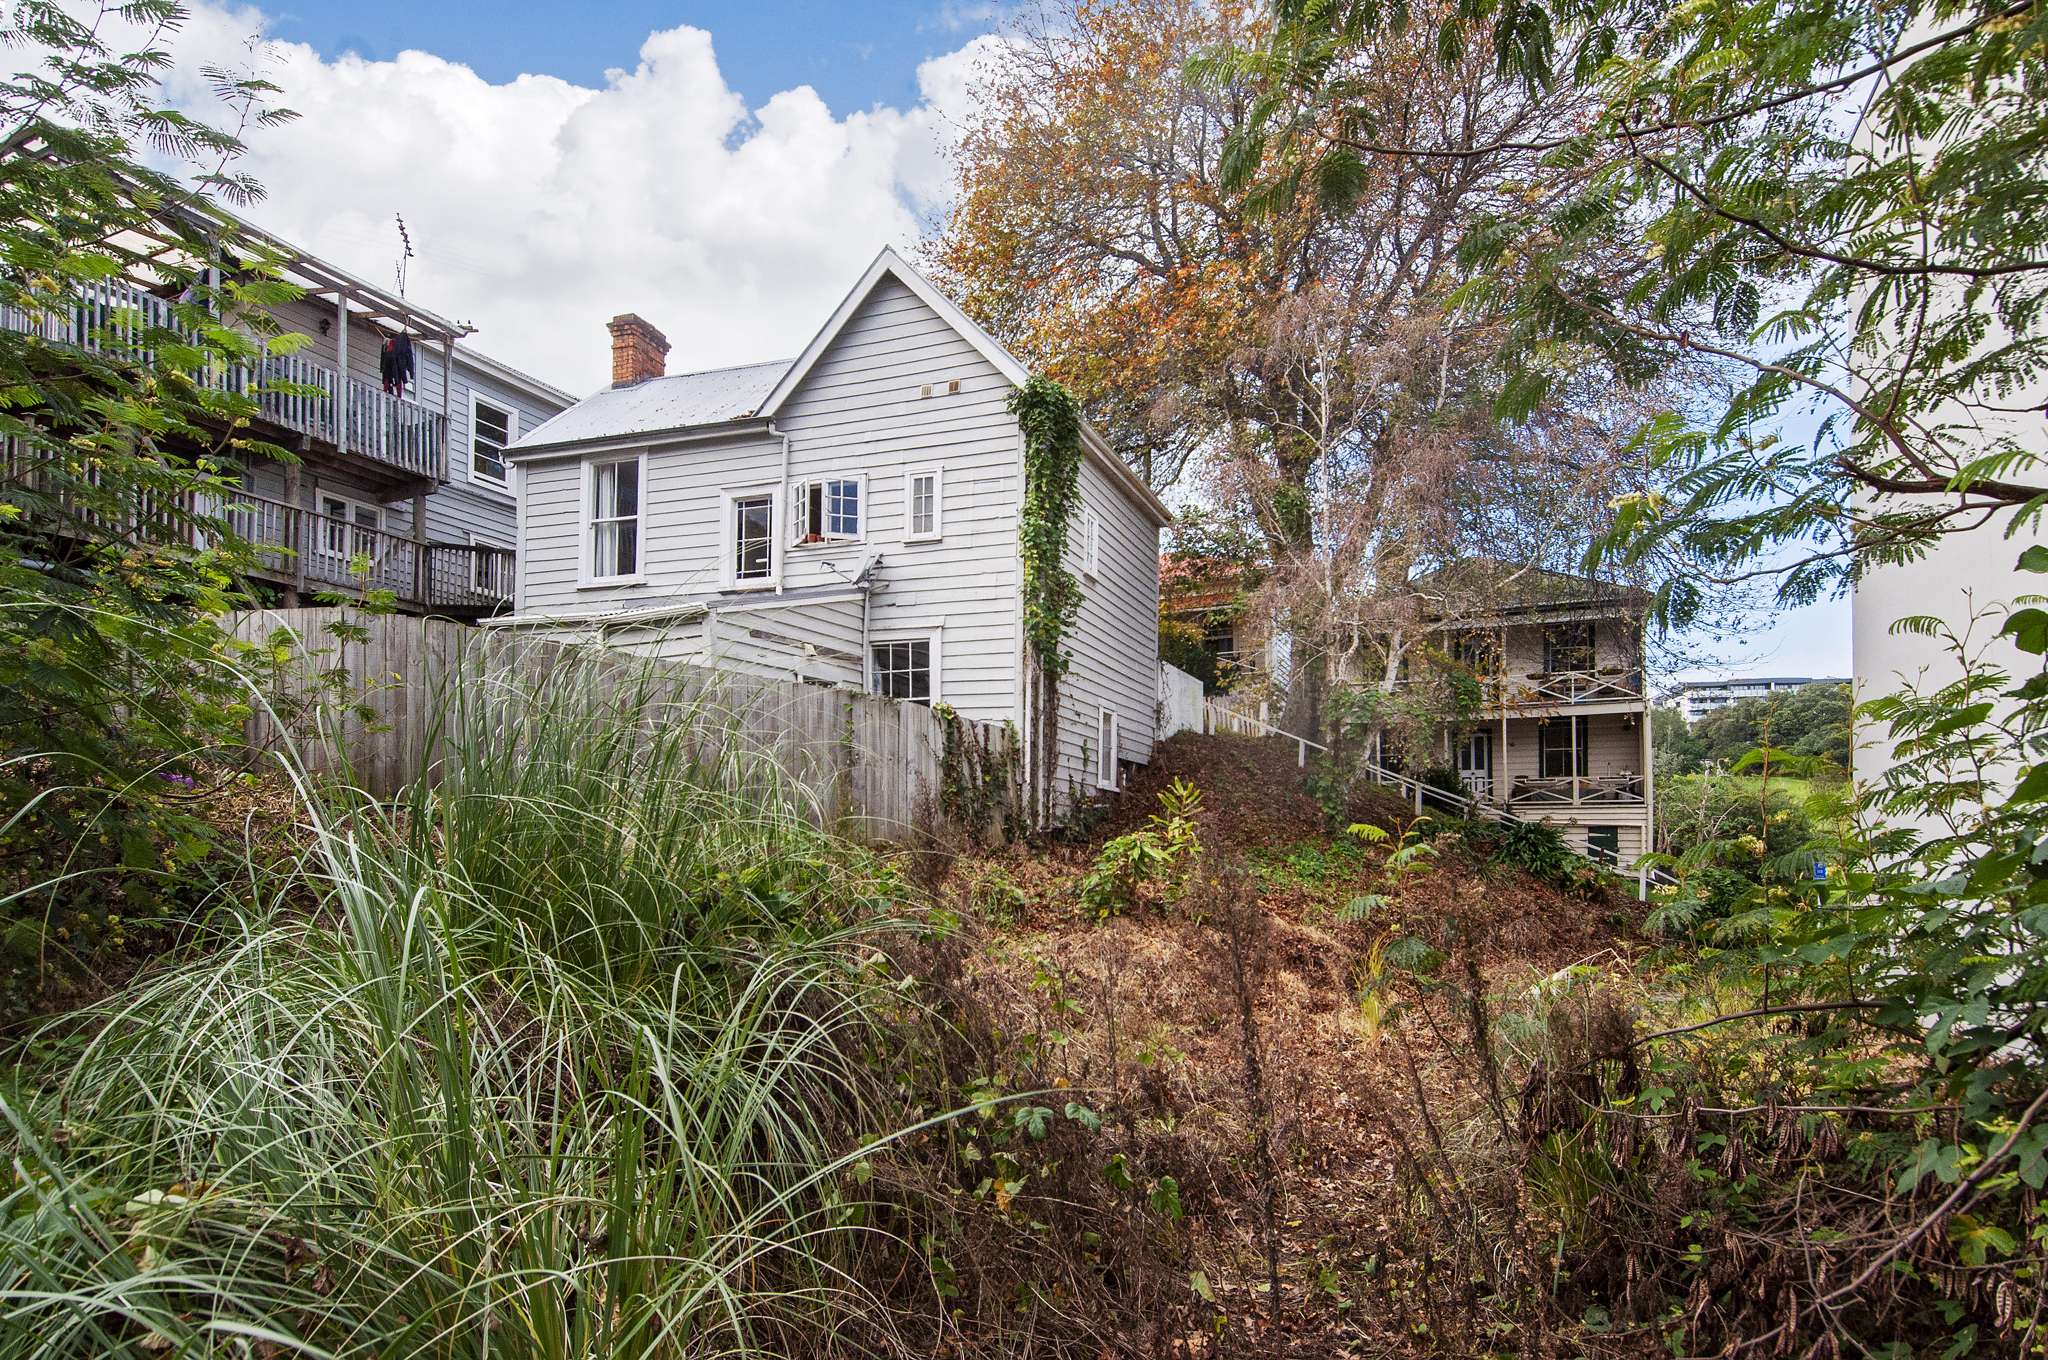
520, 281, 1020, 721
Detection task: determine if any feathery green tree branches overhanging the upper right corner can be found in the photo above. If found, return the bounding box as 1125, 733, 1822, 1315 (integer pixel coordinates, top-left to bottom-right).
1225, 0, 2048, 623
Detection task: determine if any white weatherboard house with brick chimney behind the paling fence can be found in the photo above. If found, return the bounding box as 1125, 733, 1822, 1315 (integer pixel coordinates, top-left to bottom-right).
494, 250, 1171, 819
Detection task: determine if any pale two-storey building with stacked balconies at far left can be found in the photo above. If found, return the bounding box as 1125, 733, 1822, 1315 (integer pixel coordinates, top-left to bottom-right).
0, 193, 575, 619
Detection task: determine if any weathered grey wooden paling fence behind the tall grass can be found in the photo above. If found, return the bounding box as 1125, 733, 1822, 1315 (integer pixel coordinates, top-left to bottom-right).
229, 608, 1018, 842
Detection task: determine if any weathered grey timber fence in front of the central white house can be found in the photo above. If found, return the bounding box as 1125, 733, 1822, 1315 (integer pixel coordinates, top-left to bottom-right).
229, 608, 1022, 844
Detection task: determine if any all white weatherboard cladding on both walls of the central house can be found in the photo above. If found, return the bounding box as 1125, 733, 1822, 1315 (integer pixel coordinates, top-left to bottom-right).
505, 274, 1159, 819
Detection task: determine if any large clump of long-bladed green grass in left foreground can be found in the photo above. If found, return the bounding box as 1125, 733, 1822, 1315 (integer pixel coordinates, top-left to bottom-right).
0, 643, 909, 1360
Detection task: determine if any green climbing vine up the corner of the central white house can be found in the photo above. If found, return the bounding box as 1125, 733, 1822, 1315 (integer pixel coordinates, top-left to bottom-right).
1010, 377, 1081, 819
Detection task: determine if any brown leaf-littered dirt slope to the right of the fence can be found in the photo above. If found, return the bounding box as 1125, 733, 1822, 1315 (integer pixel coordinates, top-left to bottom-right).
933, 737, 1634, 1356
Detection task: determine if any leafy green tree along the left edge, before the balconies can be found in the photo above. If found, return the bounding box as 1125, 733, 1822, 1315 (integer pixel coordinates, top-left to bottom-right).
0, 0, 295, 1008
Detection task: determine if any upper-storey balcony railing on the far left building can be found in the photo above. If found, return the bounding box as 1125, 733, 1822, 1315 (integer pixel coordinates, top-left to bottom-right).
0, 281, 449, 479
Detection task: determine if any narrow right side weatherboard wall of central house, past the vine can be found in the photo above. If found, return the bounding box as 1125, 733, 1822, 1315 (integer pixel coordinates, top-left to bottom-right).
1053, 450, 1159, 799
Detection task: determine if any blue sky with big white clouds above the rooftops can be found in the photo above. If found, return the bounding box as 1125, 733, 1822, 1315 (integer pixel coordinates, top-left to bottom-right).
182, 0, 1849, 676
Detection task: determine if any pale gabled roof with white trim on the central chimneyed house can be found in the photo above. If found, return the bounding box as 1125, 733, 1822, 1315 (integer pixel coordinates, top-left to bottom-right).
506, 246, 1174, 526
